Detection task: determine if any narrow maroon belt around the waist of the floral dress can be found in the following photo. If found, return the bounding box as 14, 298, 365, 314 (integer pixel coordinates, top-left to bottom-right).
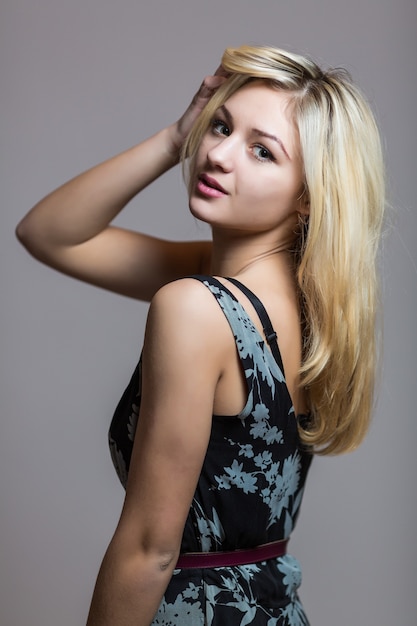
175, 539, 288, 569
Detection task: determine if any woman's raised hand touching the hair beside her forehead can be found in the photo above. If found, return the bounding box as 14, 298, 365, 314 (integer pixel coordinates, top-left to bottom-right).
167, 65, 229, 155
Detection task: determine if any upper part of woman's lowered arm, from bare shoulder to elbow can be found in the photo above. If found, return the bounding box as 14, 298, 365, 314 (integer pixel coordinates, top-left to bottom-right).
115, 280, 222, 553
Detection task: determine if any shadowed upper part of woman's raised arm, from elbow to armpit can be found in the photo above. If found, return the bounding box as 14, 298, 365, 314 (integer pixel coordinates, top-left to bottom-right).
18, 226, 211, 301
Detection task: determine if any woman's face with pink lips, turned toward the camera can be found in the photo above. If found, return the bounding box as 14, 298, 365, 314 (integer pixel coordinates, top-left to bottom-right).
190, 81, 306, 239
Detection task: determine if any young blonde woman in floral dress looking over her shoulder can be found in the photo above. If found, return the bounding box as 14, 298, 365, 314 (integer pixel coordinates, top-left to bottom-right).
17, 46, 384, 626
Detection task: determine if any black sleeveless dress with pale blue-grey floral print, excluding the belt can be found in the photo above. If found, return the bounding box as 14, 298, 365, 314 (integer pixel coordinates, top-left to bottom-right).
109, 276, 312, 626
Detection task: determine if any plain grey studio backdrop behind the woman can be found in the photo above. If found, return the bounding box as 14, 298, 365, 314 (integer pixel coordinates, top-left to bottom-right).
0, 0, 417, 626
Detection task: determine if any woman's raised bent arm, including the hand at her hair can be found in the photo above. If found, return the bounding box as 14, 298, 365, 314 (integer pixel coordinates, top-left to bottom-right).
16, 71, 224, 300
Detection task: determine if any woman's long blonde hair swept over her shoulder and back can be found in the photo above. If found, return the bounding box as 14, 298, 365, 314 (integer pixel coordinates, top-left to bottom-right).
183, 46, 384, 454
